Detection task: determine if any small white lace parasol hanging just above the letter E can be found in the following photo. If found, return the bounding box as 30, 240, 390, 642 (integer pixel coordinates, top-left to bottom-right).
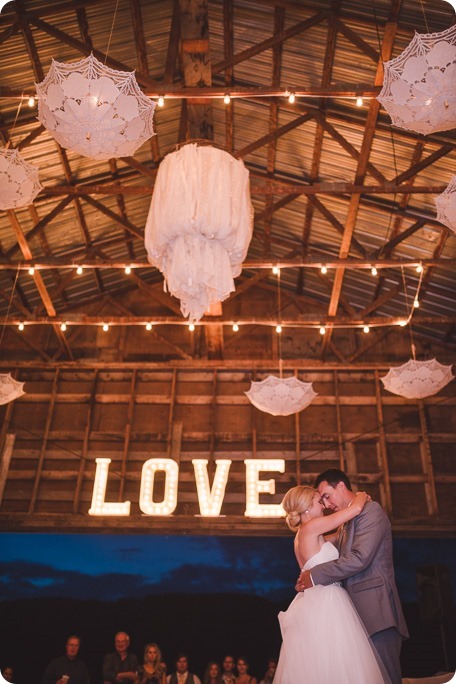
245, 375, 317, 416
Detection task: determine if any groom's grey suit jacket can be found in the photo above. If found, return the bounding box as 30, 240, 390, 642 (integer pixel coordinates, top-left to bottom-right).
312, 501, 408, 638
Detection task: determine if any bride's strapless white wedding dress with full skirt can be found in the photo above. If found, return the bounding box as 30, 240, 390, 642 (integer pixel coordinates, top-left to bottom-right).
274, 542, 389, 684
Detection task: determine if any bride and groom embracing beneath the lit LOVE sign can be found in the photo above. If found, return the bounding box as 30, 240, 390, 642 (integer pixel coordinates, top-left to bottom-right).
274, 468, 408, 684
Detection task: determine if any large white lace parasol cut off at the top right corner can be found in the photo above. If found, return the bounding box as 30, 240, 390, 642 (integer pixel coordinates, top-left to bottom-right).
378, 25, 456, 134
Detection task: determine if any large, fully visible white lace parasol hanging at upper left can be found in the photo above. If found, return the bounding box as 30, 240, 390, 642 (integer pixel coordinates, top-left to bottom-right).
36, 54, 155, 159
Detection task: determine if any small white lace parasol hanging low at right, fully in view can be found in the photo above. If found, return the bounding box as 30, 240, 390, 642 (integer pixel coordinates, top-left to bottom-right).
381, 359, 454, 399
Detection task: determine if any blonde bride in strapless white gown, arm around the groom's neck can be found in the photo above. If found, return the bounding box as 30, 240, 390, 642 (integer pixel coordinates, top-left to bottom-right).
274, 485, 390, 684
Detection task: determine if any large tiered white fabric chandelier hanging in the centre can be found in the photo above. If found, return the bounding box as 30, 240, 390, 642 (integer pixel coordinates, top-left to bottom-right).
145, 143, 253, 321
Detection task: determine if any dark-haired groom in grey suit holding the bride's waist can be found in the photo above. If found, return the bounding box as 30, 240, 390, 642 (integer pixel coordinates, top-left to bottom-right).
296, 468, 408, 684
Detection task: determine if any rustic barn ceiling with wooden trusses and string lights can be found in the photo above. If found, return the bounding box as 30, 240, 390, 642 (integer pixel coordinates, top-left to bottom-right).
0, 0, 456, 363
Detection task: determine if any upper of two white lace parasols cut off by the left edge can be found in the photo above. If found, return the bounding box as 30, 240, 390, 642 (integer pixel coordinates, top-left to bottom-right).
0, 150, 43, 210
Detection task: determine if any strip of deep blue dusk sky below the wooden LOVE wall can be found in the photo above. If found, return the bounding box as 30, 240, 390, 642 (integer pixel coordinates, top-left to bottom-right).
0, 533, 456, 602
